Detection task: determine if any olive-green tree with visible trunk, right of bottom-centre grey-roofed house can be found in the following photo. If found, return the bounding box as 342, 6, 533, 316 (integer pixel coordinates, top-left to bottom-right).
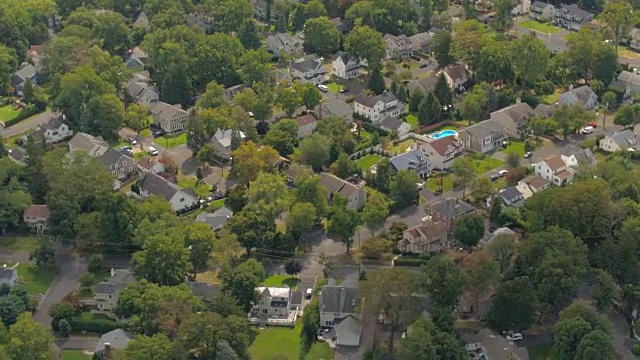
358, 268, 419, 357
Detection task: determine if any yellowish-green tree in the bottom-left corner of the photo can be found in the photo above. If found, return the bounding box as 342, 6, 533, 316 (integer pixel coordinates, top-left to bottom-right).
5, 313, 56, 360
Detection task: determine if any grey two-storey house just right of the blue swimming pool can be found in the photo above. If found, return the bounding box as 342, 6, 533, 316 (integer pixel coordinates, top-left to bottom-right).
458, 120, 507, 154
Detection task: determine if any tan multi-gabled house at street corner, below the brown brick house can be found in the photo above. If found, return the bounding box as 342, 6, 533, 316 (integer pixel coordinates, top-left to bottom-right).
398, 216, 449, 254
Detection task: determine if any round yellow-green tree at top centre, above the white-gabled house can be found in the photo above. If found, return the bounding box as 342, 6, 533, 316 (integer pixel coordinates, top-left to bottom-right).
344, 26, 386, 66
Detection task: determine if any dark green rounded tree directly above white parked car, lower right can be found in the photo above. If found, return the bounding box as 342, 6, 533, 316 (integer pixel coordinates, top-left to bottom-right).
487, 277, 536, 331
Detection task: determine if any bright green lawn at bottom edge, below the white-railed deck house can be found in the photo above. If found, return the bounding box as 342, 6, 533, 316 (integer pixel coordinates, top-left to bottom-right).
249, 321, 302, 360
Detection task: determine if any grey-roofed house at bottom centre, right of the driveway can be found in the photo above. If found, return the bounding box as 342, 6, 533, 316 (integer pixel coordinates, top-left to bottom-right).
318, 277, 362, 346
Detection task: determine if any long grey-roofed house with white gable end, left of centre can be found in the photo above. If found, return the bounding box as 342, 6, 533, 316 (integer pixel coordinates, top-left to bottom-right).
132, 173, 199, 212
